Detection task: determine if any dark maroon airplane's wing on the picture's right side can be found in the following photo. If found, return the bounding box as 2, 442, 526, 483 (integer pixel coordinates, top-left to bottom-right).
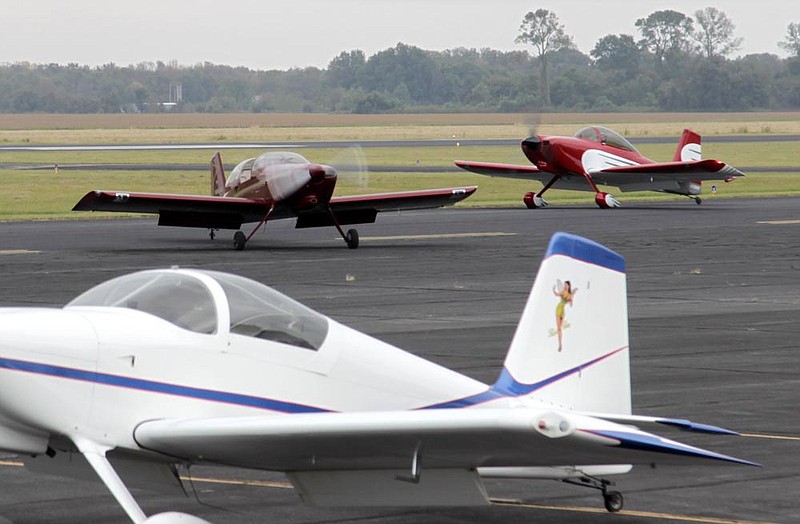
296, 186, 478, 228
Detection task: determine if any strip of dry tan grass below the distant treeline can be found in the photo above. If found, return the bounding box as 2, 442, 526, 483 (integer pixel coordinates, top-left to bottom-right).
0, 112, 800, 144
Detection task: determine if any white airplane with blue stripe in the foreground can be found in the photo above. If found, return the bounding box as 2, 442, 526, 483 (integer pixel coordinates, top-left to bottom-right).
0, 233, 756, 523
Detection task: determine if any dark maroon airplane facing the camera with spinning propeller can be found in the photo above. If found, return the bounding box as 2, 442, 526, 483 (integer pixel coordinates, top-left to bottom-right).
72, 152, 477, 250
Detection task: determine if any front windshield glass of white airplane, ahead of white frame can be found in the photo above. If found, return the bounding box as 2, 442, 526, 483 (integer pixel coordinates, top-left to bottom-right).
66, 271, 217, 334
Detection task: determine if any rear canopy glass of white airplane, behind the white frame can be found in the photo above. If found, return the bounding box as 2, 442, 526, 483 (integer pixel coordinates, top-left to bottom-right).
206, 271, 328, 350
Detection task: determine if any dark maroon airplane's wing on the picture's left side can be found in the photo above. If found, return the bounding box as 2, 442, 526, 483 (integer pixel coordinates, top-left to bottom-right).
72, 191, 278, 229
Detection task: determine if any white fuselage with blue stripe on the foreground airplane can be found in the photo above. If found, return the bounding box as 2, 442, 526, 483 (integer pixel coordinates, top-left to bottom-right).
0, 270, 507, 453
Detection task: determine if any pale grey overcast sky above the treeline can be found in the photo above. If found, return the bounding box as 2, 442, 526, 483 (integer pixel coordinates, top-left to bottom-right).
0, 0, 800, 69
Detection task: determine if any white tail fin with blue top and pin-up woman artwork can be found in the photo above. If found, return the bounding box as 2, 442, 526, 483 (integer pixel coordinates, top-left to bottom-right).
492, 233, 631, 414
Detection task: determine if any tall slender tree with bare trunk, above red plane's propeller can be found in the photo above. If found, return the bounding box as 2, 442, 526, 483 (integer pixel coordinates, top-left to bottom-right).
514, 9, 575, 107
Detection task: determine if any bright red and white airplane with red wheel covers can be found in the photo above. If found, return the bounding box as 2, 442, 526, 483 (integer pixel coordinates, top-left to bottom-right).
455, 126, 745, 209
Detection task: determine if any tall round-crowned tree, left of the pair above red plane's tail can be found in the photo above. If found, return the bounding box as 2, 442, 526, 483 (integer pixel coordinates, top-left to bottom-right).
636, 9, 692, 70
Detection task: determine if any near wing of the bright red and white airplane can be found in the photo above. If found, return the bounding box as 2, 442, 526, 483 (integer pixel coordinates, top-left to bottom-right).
590, 159, 745, 189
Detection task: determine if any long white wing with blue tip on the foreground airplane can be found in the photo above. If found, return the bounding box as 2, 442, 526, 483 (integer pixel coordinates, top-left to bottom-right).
135, 408, 752, 471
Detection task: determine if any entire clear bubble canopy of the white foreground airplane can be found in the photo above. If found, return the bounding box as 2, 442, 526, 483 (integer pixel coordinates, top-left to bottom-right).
65, 269, 328, 350
